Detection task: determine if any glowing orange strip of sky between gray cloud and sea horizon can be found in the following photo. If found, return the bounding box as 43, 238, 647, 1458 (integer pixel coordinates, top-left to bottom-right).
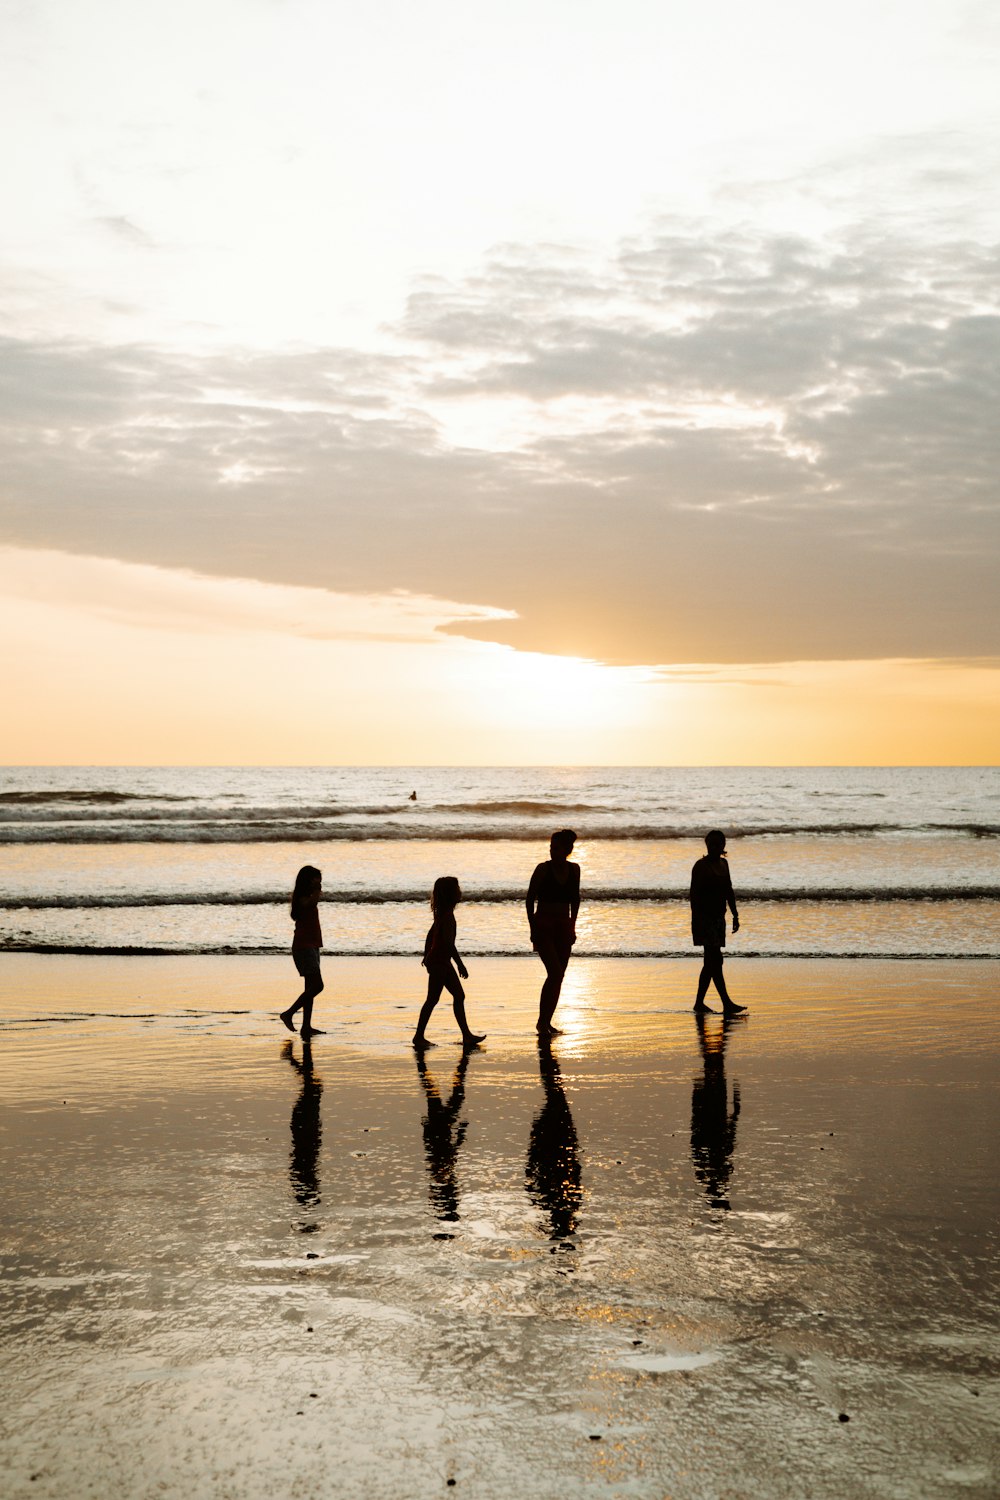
0, 549, 1000, 765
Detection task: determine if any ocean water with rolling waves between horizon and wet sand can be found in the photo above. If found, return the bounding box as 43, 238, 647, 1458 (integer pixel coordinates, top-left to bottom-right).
0, 767, 1000, 959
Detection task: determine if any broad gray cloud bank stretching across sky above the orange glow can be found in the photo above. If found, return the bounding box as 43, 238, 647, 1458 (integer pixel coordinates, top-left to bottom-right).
0, 224, 1000, 663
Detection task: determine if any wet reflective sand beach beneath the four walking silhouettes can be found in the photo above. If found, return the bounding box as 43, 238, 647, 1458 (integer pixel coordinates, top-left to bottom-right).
0, 956, 1000, 1500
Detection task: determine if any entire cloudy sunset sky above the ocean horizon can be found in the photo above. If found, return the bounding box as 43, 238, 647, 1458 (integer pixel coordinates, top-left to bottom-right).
0, 0, 1000, 764
